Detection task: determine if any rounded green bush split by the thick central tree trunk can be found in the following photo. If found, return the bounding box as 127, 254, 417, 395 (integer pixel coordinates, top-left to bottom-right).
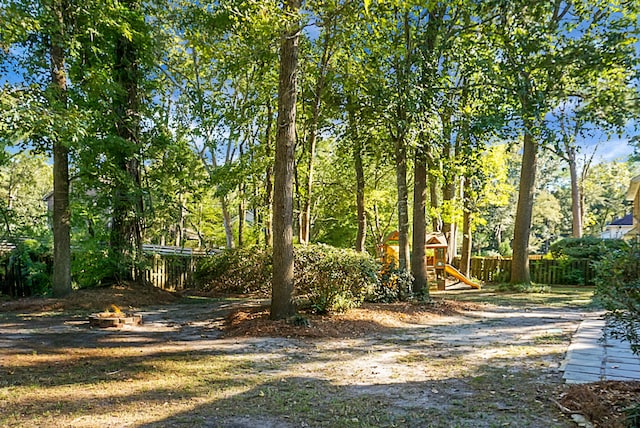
194, 244, 379, 313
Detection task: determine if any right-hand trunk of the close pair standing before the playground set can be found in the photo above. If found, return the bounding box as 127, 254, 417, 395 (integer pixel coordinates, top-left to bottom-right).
411, 144, 429, 296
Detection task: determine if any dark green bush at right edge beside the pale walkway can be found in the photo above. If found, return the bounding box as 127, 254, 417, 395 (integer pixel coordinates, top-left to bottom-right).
596, 245, 640, 354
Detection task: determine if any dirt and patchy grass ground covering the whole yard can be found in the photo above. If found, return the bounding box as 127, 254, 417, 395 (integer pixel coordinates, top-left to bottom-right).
0, 287, 640, 427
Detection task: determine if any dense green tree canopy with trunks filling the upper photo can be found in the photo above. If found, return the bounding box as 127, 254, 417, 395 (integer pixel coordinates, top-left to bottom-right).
0, 0, 640, 294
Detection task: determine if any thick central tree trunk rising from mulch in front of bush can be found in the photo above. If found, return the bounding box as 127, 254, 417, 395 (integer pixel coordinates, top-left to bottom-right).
271, 0, 300, 319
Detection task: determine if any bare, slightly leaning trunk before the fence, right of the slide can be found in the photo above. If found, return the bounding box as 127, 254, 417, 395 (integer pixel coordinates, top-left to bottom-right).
511, 130, 538, 284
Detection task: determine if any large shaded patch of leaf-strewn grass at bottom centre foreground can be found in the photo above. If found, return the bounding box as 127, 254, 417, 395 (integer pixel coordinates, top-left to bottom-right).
141, 367, 571, 428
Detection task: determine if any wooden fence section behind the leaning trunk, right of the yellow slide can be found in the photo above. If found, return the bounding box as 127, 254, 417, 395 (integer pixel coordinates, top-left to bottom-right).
464, 256, 595, 285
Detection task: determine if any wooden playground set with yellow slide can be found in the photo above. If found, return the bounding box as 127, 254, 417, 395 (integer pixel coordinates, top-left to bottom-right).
380, 231, 480, 290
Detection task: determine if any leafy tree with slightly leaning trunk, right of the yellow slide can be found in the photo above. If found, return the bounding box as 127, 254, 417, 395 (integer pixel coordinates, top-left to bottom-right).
484, 0, 638, 284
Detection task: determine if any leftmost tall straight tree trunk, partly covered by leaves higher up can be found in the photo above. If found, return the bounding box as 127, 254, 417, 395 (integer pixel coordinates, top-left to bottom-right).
50, 0, 71, 297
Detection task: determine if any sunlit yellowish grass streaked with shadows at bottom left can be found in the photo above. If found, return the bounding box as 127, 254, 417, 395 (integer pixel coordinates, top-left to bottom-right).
0, 356, 263, 426
